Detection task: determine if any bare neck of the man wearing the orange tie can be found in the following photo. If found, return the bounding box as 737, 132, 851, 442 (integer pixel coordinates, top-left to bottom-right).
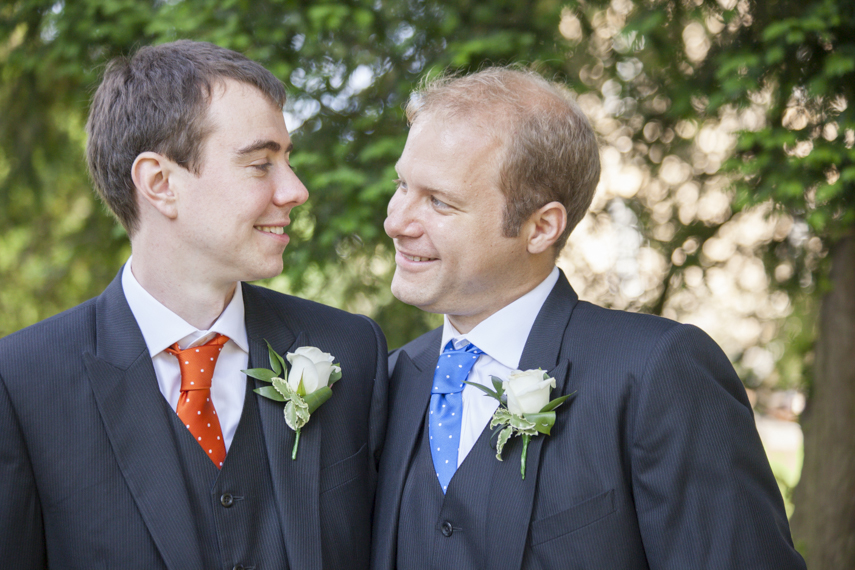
131, 244, 237, 330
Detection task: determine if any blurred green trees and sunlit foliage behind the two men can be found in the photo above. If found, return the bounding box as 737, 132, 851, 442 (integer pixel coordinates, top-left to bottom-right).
0, 0, 855, 560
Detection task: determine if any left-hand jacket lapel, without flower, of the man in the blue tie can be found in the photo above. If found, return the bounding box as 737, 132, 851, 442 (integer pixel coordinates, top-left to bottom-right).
372, 328, 442, 568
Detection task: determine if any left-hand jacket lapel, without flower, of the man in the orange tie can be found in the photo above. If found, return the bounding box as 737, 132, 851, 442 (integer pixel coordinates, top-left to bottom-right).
83, 271, 203, 569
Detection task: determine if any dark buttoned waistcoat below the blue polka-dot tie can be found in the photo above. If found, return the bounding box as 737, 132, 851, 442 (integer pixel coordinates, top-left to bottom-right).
397, 408, 497, 570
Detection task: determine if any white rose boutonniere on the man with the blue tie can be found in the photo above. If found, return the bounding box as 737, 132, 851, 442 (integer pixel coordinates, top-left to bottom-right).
467, 369, 575, 479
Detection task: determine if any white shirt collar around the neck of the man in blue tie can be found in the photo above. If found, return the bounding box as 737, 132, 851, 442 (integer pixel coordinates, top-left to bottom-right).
440, 267, 558, 369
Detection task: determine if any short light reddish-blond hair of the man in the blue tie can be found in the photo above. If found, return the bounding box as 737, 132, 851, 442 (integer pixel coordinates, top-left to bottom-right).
407, 67, 600, 251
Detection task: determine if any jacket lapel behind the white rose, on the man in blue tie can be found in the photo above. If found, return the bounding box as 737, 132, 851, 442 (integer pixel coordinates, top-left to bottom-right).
487, 273, 578, 570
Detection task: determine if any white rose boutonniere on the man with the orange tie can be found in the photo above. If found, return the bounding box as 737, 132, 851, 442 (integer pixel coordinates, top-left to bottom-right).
242, 341, 341, 460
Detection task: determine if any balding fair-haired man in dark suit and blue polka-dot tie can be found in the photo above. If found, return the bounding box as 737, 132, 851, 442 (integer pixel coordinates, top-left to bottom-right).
372, 68, 804, 570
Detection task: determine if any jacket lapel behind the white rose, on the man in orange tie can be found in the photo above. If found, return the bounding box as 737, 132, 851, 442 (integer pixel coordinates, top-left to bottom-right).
243, 285, 323, 570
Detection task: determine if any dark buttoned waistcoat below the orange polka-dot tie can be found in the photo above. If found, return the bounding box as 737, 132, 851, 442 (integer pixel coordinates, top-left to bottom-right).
172, 383, 288, 570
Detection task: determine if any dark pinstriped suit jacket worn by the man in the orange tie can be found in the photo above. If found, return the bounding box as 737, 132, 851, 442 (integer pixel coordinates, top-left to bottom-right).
0, 270, 387, 570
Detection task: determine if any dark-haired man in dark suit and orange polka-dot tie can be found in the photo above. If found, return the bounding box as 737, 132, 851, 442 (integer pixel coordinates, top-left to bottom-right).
0, 41, 387, 570
